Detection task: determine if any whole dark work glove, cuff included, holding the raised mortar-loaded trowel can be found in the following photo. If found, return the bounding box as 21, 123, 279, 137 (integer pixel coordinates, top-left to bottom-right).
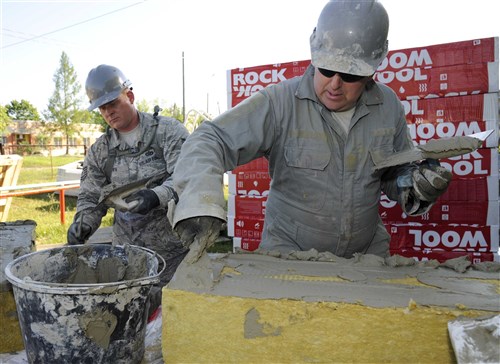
397, 160, 452, 216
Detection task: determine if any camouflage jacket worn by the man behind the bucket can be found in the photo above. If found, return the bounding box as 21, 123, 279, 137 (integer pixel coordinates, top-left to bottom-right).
77, 112, 189, 249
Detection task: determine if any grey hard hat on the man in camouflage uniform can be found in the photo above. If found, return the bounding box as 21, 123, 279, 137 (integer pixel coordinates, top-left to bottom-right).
85, 64, 132, 111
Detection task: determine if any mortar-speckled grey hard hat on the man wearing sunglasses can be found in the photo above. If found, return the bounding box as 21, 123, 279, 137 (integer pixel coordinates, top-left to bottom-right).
310, 0, 389, 76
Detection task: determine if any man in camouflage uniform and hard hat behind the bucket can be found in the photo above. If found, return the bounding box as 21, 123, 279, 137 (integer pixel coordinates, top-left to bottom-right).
68, 65, 189, 312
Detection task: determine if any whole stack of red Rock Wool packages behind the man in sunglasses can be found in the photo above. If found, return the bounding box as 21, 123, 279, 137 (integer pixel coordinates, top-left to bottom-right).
228, 37, 500, 262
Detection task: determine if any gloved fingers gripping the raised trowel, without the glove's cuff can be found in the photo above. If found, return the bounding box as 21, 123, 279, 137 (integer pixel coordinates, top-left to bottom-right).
412, 161, 452, 202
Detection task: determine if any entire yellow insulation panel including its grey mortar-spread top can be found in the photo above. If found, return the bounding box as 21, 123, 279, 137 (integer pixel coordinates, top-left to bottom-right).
162, 252, 500, 363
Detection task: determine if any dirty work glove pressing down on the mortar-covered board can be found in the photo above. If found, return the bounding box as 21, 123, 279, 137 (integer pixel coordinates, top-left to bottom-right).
175, 216, 225, 251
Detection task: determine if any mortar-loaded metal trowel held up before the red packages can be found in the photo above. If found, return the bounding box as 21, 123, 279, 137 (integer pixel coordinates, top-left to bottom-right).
374, 130, 493, 171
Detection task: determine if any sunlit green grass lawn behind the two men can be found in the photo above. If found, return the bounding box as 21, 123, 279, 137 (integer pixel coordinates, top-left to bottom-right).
7, 155, 232, 253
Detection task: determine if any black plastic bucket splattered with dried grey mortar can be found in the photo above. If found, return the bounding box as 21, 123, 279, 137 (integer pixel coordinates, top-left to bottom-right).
5, 244, 165, 364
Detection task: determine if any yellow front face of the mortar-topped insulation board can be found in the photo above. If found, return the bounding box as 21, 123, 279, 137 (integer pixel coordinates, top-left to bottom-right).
162, 289, 492, 363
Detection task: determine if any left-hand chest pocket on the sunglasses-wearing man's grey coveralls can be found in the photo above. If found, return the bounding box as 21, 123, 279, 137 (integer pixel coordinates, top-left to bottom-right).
281, 146, 331, 211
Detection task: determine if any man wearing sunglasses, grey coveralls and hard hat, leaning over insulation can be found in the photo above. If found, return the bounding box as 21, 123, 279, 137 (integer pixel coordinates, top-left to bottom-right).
173, 0, 451, 258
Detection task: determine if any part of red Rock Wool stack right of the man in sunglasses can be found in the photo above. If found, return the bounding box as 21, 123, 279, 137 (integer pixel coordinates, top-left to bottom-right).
374, 37, 499, 262
